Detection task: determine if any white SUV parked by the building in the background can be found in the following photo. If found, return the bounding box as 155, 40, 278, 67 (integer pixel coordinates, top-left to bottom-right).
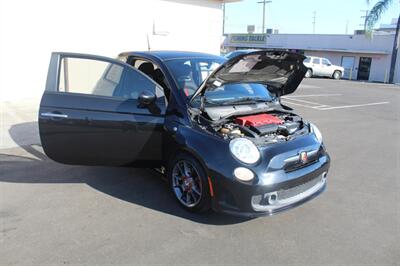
304, 56, 344, 79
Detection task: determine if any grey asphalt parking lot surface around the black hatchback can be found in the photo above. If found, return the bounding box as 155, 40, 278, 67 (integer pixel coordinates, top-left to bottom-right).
0, 79, 400, 265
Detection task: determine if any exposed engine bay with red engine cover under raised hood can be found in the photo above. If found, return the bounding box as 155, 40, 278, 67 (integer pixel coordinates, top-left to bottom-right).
198, 111, 309, 144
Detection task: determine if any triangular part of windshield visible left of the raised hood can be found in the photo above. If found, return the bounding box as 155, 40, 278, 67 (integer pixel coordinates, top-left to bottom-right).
165, 58, 225, 98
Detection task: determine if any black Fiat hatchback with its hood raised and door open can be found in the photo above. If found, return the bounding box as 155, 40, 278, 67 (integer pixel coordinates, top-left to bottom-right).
39, 51, 330, 217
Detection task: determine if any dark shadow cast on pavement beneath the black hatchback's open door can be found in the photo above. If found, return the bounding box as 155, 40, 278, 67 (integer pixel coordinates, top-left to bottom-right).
0, 122, 249, 225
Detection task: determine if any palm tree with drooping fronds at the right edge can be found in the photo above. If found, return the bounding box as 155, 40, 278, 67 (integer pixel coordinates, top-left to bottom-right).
366, 0, 400, 83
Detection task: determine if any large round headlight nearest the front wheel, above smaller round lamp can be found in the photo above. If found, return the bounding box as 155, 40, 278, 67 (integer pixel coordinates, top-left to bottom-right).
229, 138, 260, 164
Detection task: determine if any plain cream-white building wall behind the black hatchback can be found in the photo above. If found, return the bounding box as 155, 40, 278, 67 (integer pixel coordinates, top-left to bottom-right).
0, 0, 222, 101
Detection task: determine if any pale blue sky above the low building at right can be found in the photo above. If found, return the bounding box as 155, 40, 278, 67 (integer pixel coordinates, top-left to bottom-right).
225, 0, 400, 34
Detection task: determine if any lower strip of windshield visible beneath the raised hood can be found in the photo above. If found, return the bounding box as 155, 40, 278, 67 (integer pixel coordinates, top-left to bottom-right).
193, 83, 275, 105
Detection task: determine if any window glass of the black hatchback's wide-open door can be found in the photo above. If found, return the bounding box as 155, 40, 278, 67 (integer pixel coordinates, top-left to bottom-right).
58, 57, 163, 99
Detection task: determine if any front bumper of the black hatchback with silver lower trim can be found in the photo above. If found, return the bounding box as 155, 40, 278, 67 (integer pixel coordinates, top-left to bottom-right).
213, 153, 330, 217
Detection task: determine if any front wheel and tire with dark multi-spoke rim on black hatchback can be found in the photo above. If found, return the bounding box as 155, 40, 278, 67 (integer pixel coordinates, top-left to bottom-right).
167, 153, 211, 212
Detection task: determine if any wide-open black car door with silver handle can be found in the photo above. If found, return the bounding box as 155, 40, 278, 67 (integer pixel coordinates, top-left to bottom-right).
39, 53, 167, 167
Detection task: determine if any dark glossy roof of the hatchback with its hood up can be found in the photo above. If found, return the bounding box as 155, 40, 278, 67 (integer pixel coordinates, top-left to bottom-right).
119, 51, 224, 61
